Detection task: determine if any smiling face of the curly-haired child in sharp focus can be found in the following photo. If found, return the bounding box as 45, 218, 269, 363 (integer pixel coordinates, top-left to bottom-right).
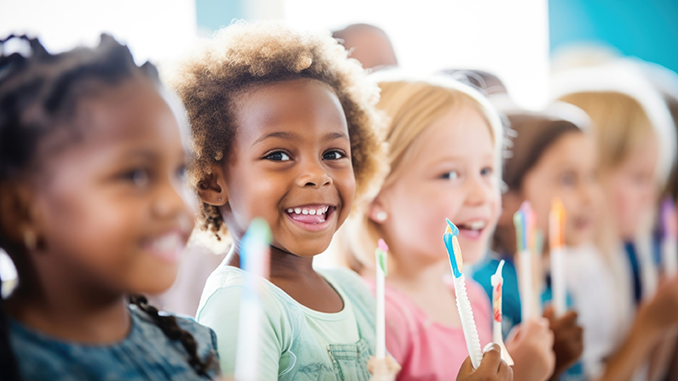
216, 79, 356, 257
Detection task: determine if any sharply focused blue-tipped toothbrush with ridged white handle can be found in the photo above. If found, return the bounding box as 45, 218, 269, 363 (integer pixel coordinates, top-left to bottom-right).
443, 220, 483, 369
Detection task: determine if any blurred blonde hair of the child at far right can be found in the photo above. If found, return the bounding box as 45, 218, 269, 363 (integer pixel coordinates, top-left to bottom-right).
561, 92, 656, 173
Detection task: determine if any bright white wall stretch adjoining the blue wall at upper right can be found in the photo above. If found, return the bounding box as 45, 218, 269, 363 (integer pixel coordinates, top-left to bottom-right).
284, 0, 549, 108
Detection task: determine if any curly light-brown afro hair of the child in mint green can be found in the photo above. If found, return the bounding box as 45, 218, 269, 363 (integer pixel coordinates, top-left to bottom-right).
167, 21, 386, 239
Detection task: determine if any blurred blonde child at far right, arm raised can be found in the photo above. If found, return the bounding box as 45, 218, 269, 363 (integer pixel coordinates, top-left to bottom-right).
554, 60, 678, 380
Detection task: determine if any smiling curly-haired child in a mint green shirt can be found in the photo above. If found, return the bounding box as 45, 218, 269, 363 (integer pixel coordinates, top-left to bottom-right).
169, 23, 510, 380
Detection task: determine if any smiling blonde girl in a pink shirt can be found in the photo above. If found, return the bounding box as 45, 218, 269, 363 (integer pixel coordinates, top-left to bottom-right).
341, 72, 553, 380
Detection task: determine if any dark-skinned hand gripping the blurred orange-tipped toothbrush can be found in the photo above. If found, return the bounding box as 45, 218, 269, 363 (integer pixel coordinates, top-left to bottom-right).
544, 306, 584, 379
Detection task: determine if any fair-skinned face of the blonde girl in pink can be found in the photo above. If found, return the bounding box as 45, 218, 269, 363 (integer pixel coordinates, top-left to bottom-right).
375, 106, 500, 264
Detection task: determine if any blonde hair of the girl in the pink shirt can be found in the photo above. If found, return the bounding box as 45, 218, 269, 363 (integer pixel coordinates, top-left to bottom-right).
338, 78, 503, 271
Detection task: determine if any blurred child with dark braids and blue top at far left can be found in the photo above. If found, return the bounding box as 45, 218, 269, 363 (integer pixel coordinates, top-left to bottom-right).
0, 35, 217, 380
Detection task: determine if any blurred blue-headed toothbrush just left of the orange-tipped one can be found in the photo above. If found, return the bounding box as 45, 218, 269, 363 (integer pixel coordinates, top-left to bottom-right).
513, 201, 535, 321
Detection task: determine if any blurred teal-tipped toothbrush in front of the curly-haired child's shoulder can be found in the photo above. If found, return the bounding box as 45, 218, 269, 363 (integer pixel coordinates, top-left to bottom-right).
234, 218, 271, 381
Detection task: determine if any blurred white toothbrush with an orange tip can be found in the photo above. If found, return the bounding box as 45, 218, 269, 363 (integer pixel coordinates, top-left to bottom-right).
549, 198, 567, 317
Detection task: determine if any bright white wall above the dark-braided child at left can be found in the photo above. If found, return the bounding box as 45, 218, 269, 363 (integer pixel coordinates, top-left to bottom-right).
0, 0, 198, 63
